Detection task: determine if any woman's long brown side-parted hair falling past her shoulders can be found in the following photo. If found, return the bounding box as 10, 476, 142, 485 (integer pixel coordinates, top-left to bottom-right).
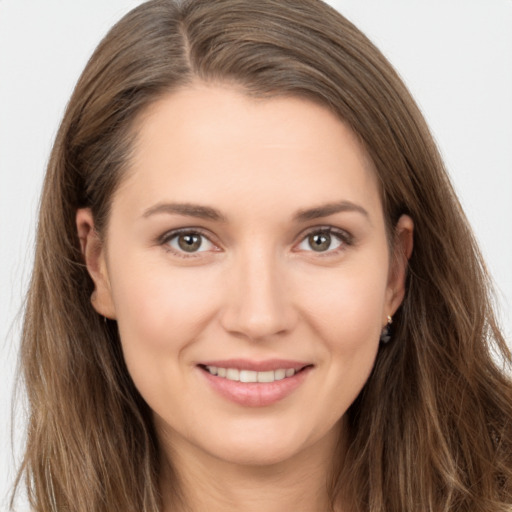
12, 0, 512, 512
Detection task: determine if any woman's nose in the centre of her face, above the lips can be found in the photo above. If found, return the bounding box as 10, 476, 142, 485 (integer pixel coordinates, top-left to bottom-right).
221, 250, 297, 341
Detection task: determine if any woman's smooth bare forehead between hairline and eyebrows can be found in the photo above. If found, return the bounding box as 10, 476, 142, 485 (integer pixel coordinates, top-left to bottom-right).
115, 84, 381, 221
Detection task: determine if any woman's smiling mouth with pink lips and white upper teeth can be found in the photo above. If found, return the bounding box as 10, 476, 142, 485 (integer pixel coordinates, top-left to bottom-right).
198, 359, 313, 407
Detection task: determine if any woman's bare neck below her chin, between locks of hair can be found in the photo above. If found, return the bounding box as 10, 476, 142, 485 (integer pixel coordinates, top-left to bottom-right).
161, 422, 341, 512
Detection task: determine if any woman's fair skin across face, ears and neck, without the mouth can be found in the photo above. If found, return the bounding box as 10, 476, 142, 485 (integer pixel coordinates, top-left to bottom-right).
77, 83, 413, 512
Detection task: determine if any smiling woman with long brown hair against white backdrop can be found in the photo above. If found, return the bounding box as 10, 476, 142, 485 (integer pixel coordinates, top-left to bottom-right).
12, 0, 512, 512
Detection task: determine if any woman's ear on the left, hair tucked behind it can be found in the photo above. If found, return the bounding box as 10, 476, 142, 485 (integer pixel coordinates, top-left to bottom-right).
76, 208, 116, 319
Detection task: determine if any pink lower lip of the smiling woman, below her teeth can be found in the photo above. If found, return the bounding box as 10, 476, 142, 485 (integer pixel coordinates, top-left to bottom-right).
199, 367, 312, 407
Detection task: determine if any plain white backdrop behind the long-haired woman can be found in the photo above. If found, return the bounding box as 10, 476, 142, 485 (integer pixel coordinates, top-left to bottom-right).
0, 0, 512, 511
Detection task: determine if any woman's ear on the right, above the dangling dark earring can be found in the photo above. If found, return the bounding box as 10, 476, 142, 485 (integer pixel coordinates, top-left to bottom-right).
383, 215, 414, 318
